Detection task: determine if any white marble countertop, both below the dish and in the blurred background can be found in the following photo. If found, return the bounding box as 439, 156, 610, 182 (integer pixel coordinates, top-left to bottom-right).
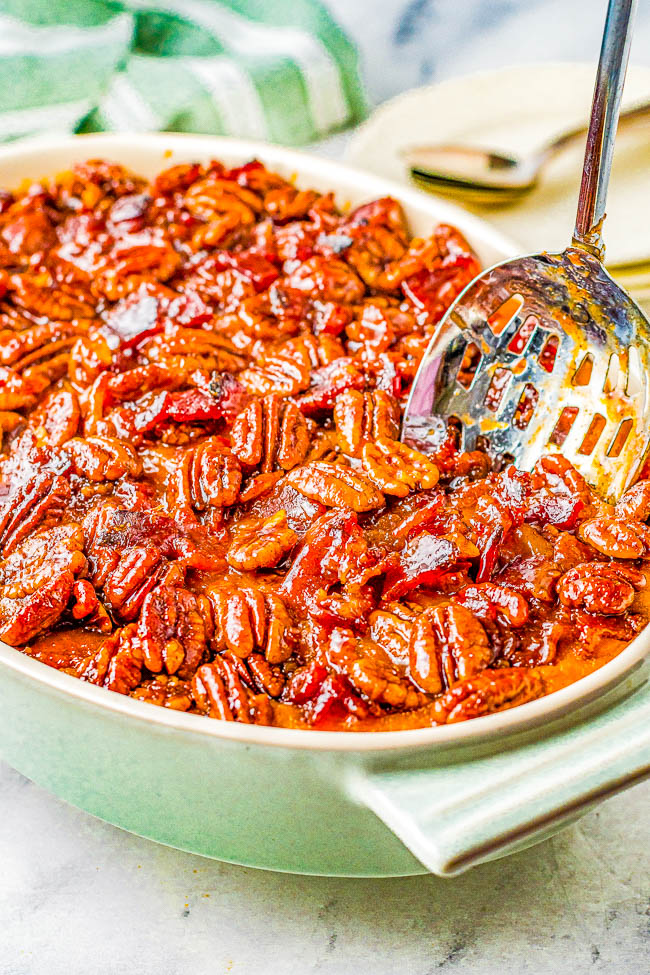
0, 0, 650, 975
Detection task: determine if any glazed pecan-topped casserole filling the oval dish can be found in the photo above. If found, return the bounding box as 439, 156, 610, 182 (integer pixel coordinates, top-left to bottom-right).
0, 160, 650, 730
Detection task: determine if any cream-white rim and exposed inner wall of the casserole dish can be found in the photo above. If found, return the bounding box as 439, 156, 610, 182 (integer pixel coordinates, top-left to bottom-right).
0, 133, 650, 752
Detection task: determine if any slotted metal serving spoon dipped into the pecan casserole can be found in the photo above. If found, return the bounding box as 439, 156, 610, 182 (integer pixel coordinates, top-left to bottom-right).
402, 0, 650, 497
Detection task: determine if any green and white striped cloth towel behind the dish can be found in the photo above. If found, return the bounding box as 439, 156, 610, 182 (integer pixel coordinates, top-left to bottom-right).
0, 0, 366, 145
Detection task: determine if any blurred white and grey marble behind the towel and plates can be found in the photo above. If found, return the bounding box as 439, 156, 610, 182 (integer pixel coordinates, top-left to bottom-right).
325, 0, 650, 104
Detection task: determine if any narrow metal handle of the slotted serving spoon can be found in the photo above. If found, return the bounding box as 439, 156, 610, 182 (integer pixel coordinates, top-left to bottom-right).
573, 0, 636, 261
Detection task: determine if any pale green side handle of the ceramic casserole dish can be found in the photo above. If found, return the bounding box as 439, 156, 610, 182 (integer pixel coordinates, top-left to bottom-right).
351, 682, 650, 877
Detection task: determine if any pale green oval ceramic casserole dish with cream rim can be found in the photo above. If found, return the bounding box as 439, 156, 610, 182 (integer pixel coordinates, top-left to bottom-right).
0, 135, 650, 876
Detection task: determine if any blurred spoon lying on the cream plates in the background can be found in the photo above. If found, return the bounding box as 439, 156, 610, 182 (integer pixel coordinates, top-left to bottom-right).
401, 102, 650, 205
